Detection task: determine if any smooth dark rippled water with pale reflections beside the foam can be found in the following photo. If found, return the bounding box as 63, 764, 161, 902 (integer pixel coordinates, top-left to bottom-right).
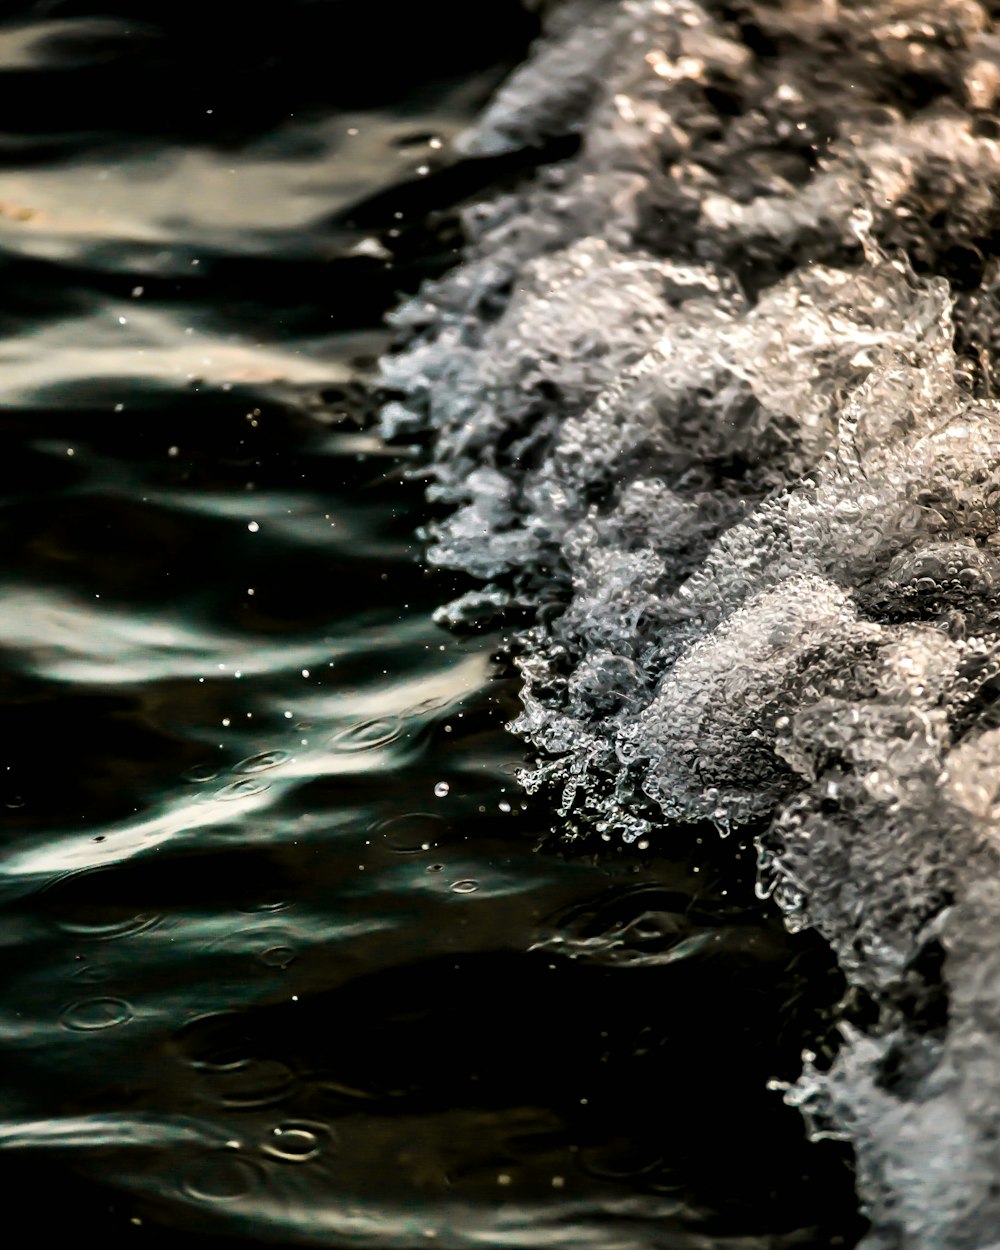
0, 0, 858, 1250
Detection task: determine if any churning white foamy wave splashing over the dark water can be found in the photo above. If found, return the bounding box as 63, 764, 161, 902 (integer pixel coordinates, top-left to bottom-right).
383, 0, 1000, 1250
